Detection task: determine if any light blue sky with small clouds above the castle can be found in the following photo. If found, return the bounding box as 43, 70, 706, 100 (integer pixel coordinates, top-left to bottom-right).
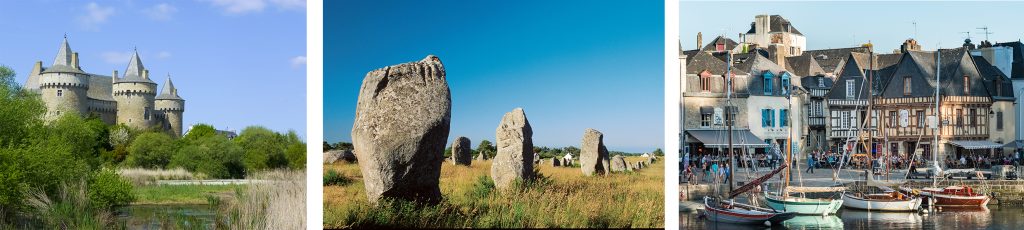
0, 0, 306, 137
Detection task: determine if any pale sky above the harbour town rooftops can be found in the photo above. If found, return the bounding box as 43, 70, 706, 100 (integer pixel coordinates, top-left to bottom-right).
679, 1, 1024, 53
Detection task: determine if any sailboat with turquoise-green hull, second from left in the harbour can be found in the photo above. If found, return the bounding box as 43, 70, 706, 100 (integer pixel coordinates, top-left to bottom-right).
764, 56, 843, 216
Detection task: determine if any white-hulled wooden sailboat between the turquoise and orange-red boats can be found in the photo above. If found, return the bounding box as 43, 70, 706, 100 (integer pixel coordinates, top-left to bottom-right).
843, 43, 921, 212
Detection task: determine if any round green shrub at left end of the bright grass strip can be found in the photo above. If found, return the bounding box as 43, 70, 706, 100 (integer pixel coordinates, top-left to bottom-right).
89, 169, 135, 210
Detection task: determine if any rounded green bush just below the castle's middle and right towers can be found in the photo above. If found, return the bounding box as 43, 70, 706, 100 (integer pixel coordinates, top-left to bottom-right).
125, 132, 176, 169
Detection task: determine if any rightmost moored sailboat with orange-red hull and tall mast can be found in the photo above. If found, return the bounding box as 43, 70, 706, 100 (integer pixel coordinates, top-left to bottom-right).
900, 50, 991, 206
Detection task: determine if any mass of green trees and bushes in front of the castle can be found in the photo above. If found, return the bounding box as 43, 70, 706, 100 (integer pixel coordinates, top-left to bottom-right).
0, 65, 306, 229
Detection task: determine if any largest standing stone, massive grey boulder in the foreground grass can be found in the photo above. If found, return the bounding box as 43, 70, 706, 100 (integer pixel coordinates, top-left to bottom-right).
352, 55, 452, 203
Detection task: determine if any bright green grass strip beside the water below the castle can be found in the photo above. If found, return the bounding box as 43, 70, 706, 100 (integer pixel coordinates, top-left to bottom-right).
133, 185, 245, 204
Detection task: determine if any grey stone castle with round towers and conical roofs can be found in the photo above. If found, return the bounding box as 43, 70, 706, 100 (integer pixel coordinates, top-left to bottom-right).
25, 36, 185, 137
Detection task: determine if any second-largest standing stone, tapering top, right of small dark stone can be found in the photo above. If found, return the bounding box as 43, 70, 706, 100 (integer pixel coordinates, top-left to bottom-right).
490, 108, 534, 189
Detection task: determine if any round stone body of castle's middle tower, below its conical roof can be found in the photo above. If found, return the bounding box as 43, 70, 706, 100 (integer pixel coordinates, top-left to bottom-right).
114, 82, 157, 130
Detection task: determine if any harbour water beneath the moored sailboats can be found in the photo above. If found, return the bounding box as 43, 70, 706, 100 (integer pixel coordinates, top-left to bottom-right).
679, 205, 1024, 230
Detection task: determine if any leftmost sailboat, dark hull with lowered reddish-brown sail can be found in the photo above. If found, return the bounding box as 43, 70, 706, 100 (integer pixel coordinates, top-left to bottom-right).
703, 44, 796, 225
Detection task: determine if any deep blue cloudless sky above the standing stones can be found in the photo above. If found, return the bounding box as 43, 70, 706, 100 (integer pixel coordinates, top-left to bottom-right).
324, 0, 665, 152
